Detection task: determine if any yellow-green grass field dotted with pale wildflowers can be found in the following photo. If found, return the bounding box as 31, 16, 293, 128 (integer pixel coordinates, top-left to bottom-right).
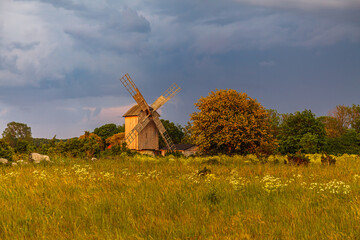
0, 155, 360, 239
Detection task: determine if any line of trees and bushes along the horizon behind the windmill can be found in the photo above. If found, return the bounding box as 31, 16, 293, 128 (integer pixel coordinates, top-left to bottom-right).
0, 90, 360, 159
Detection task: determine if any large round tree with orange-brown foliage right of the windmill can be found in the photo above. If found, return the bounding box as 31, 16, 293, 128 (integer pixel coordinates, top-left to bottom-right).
190, 89, 276, 154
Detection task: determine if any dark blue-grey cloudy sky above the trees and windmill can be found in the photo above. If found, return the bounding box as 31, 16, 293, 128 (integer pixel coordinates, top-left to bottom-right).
0, 0, 360, 139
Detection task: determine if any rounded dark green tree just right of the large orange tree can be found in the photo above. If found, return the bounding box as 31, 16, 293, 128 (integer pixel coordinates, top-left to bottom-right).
278, 109, 326, 154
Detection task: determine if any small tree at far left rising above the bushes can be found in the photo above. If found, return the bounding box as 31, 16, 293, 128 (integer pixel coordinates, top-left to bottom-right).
2, 122, 32, 148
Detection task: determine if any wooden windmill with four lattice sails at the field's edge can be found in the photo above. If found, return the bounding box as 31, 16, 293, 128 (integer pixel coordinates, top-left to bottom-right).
120, 74, 181, 150
